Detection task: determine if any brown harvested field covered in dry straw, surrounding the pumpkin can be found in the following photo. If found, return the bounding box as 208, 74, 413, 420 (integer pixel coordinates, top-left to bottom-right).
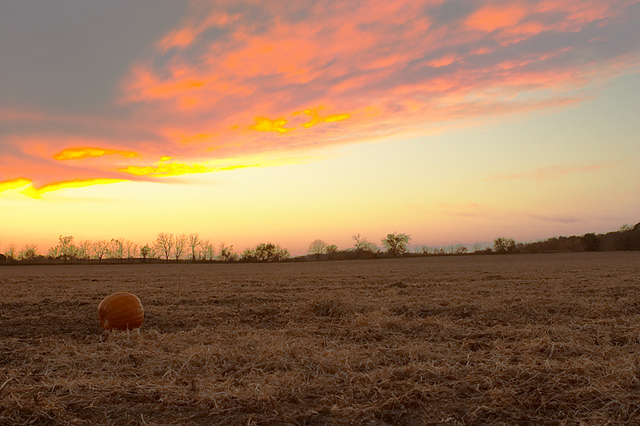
0, 253, 640, 426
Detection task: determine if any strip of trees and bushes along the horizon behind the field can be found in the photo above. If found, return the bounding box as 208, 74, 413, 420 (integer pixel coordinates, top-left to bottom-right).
0, 223, 640, 264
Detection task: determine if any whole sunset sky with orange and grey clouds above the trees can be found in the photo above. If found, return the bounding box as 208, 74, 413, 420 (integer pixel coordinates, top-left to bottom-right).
0, 0, 640, 254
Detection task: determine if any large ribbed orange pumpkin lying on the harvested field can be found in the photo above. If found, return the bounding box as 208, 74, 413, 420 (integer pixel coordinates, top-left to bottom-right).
98, 291, 144, 330
